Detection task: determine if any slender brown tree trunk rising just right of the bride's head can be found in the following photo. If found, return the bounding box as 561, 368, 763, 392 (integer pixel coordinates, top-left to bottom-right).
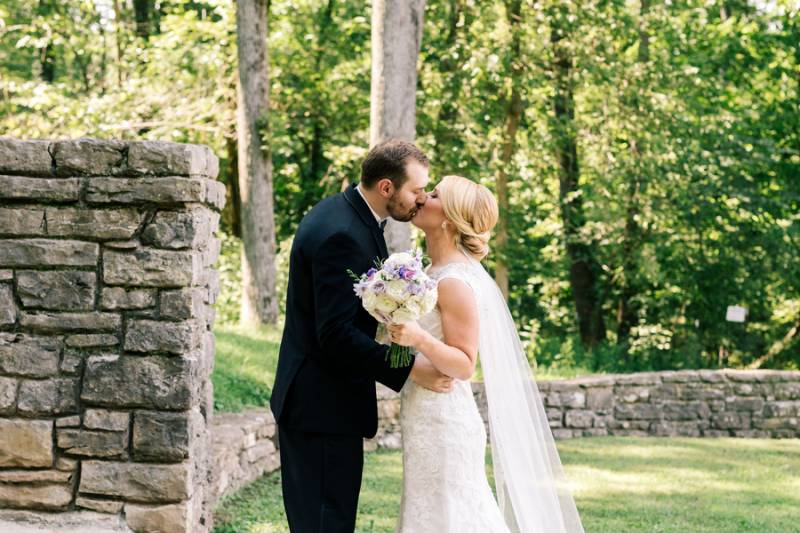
494, 0, 522, 300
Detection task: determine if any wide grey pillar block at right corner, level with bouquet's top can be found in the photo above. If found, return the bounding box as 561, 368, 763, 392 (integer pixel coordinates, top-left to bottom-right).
103, 248, 201, 287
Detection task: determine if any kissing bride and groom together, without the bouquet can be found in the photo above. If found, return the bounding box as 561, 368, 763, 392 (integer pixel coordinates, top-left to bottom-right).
270, 139, 583, 533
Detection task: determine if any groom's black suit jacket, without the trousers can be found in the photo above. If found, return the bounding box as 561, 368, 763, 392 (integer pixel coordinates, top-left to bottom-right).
270, 185, 411, 438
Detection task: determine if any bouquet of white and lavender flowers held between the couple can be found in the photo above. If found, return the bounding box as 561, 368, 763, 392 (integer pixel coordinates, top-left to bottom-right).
348, 250, 438, 368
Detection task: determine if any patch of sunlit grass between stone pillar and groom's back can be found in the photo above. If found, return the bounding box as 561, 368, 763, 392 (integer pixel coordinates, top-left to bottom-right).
211, 325, 280, 412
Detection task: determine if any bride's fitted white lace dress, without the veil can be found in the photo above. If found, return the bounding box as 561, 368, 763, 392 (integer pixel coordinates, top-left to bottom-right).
397, 263, 509, 533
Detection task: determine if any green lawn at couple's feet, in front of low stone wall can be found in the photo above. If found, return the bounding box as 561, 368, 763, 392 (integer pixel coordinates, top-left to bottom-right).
209, 437, 800, 533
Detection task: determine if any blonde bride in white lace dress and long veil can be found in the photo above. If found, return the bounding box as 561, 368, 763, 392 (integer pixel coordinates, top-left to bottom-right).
389, 176, 583, 533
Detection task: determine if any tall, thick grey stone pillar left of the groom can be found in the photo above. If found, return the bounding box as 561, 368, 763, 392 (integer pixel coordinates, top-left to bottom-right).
0, 138, 225, 533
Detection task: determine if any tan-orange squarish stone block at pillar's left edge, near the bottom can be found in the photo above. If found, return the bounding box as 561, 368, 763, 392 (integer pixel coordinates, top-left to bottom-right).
0, 418, 53, 468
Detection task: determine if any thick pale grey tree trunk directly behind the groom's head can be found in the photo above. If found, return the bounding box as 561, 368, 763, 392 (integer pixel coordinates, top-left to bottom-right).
369, 0, 425, 253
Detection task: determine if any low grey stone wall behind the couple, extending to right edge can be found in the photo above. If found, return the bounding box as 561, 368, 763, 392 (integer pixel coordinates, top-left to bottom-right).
369, 370, 800, 449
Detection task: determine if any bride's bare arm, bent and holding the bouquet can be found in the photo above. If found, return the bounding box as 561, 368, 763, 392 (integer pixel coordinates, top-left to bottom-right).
388, 278, 478, 380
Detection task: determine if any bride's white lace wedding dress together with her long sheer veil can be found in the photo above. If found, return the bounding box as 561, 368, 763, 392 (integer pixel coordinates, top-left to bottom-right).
396, 250, 583, 533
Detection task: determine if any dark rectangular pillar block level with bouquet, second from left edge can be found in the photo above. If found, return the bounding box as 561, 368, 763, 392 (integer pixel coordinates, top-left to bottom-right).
17, 270, 97, 311
